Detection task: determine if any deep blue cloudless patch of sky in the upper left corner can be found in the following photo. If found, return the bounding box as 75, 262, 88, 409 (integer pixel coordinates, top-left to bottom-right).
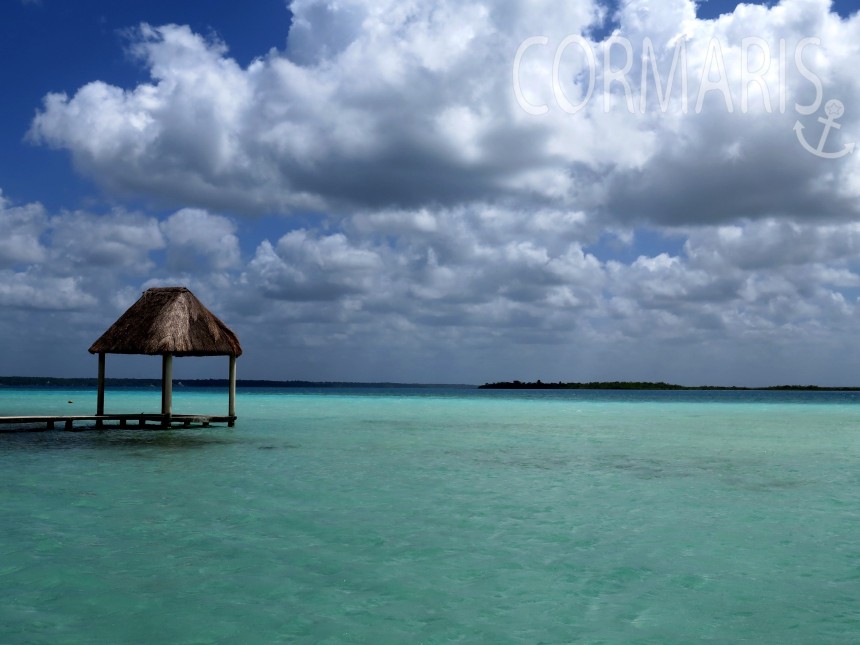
0, 0, 290, 207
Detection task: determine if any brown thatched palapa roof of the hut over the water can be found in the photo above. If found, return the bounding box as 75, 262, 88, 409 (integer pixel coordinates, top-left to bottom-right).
90, 287, 242, 356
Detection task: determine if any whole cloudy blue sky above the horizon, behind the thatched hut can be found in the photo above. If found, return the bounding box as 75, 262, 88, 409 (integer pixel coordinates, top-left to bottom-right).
0, 0, 860, 384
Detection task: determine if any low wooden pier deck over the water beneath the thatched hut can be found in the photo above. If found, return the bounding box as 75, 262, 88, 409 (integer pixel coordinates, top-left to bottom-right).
0, 413, 236, 432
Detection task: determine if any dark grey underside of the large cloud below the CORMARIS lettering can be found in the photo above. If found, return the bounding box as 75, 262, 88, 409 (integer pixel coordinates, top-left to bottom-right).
601, 109, 860, 226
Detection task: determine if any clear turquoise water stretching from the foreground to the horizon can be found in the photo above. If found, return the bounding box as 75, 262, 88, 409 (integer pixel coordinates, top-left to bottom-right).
0, 388, 860, 645
